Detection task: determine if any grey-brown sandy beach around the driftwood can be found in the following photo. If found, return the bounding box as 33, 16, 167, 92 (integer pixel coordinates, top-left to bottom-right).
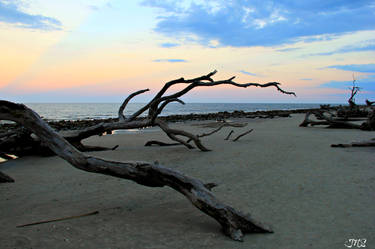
0, 114, 375, 249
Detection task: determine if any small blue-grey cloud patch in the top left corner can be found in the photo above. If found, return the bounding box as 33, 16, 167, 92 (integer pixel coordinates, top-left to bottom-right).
0, 1, 62, 30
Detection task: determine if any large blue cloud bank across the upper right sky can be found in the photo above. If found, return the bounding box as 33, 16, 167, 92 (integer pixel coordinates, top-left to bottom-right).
143, 0, 375, 47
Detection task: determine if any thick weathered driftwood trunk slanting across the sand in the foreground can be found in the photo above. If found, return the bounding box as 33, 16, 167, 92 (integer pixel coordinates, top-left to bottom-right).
0, 101, 272, 241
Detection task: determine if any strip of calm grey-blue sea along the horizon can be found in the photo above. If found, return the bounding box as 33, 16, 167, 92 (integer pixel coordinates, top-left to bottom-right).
26, 103, 328, 120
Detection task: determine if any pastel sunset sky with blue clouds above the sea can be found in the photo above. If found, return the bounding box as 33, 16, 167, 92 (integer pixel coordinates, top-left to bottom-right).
0, 0, 375, 103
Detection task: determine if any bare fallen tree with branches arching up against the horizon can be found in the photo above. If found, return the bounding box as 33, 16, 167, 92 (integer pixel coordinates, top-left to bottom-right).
0, 70, 295, 156
